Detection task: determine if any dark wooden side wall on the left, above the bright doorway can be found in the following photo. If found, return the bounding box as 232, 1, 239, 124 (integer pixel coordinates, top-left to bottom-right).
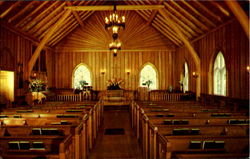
0, 25, 54, 96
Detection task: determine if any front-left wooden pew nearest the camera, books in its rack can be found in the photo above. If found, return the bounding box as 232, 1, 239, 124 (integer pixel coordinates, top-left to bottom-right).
0, 135, 75, 159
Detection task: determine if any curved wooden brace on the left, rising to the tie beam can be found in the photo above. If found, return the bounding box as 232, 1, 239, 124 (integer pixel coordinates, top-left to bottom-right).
26, 10, 71, 79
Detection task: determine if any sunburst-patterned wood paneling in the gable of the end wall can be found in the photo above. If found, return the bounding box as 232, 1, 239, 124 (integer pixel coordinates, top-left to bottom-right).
57, 11, 173, 51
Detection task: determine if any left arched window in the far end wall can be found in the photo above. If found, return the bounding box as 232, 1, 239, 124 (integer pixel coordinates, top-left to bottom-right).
73, 64, 91, 89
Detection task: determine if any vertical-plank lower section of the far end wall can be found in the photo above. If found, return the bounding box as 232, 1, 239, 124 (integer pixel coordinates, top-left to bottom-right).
52, 51, 173, 90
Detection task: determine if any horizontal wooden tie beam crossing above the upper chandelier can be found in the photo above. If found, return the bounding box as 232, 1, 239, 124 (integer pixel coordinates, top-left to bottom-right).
65, 5, 164, 11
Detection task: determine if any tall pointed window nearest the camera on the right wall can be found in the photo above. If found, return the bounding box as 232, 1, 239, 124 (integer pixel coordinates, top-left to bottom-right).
214, 52, 227, 96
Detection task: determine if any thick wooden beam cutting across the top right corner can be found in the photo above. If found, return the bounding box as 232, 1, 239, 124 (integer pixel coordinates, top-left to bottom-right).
225, 0, 250, 39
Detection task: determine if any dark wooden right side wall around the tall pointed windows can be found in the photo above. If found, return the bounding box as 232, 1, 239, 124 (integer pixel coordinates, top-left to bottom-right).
174, 20, 249, 99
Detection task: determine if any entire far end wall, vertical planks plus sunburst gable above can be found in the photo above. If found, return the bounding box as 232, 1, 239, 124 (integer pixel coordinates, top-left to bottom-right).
55, 11, 175, 90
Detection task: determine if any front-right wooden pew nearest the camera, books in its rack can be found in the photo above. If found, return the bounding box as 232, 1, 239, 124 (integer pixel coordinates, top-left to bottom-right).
157, 133, 249, 159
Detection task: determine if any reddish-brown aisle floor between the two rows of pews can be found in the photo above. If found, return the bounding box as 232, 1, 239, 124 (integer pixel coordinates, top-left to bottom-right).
90, 106, 142, 159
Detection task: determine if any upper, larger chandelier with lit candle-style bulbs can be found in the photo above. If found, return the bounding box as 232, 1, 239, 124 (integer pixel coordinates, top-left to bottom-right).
105, 5, 125, 40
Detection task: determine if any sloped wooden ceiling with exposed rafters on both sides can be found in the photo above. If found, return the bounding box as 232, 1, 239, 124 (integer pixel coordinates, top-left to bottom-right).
0, 0, 246, 47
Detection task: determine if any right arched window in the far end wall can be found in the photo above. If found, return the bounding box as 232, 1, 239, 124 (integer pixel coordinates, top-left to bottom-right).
140, 64, 157, 90
